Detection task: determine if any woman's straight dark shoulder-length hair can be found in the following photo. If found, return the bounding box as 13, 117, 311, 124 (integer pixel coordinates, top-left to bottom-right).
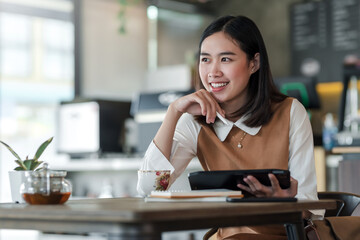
196, 16, 286, 127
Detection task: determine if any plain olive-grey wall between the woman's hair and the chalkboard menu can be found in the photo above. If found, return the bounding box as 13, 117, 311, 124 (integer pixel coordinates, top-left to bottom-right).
220, 0, 302, 77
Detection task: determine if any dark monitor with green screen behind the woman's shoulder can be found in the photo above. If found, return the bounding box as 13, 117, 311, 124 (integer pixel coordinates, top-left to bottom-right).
274, 76, 320, 109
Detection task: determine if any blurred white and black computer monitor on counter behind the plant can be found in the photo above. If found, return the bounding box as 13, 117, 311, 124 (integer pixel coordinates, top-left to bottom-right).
57, 99, 131, 158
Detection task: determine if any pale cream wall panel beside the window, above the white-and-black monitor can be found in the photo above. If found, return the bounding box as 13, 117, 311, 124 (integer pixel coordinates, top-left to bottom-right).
81, 0, 147, 99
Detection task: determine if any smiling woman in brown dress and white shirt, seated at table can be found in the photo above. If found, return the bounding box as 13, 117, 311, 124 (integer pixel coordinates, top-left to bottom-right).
138, 16, 323, 239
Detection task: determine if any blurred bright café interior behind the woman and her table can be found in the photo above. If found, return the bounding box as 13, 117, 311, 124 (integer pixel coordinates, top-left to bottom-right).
0, 0, 360, 240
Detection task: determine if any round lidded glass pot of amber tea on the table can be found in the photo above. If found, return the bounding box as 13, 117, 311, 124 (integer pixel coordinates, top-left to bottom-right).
20, 166, 72, 204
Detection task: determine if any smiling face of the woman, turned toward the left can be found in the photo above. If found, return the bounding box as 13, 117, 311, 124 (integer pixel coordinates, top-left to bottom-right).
199, 32, 257, 109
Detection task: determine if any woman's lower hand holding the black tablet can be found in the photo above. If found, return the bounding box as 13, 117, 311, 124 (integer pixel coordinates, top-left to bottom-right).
237, 173, 298, 197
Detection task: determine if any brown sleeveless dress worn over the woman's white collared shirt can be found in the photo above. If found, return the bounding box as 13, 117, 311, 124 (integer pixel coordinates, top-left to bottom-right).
197, 98, 293, 240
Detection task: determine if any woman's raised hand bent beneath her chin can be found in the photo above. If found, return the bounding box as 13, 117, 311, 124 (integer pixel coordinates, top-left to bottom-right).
172, 89, 225, 123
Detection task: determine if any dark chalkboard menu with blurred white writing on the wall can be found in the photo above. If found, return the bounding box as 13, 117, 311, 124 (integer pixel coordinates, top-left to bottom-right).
290, 0, 360, 82
